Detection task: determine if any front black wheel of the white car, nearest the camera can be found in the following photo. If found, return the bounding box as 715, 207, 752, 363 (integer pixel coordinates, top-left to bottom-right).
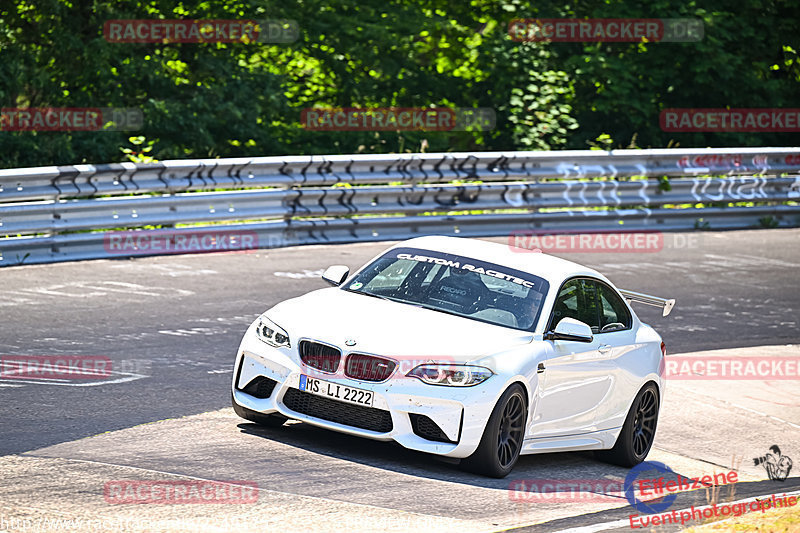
460, 383, 528, 478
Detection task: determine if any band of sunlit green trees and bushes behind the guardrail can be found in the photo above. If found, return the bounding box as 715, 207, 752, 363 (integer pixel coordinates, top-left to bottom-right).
0, 0, 800, 167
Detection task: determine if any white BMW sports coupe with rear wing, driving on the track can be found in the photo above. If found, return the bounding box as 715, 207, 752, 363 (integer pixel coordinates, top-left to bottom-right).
231, 237, 674, 477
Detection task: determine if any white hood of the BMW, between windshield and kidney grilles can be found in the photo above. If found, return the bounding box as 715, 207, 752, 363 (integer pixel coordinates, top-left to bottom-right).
266, 288, 533, 363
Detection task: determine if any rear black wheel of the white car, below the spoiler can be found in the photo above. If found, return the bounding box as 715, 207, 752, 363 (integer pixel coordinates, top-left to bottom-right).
595, 383, 659, 467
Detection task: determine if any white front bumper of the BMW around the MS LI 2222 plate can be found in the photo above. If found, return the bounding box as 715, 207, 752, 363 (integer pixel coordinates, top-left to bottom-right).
232, 328, 506, 458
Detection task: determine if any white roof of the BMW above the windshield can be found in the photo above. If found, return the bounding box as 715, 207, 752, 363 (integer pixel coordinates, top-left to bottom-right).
392, 235, 610, 288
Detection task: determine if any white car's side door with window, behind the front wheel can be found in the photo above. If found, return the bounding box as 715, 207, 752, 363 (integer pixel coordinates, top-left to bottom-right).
529, 278, 609, 437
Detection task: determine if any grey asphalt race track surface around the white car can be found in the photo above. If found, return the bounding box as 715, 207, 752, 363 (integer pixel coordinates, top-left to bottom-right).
0, 230, 800, 531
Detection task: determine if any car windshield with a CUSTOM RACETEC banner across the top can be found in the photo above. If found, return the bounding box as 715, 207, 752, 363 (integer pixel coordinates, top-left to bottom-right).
342, 248, 548, 331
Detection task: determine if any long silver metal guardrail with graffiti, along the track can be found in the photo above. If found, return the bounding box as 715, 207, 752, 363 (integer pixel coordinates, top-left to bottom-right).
0, 148, 800, 266
